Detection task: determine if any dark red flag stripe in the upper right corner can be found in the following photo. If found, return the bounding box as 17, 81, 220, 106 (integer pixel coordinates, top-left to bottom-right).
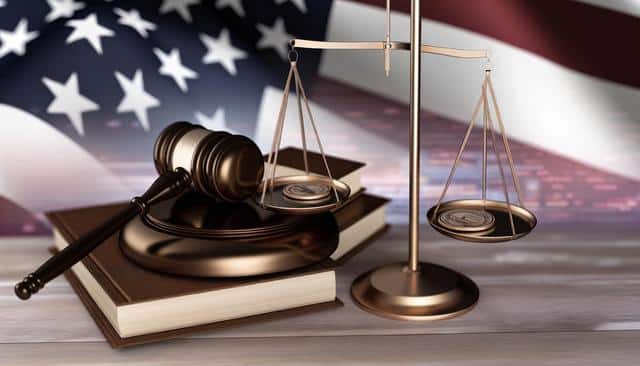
355, 0, 640, 87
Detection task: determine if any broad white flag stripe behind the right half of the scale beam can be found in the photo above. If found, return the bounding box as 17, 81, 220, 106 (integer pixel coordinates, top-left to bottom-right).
320, 0, 640, 179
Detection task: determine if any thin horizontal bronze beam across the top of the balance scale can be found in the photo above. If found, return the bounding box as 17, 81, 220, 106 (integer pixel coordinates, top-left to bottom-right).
291, 39, 489, 58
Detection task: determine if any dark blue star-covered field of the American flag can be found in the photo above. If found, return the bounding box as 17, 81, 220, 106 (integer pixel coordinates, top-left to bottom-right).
0, 0, 331, 157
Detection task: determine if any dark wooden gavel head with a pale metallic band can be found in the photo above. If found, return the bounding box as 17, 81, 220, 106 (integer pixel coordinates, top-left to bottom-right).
153, 122, 264, 202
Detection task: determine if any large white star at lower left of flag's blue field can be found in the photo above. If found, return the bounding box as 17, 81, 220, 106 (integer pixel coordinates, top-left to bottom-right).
42, 72, 100, 136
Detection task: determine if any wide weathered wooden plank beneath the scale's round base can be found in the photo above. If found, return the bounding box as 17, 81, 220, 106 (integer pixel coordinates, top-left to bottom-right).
0, 227, 640, 343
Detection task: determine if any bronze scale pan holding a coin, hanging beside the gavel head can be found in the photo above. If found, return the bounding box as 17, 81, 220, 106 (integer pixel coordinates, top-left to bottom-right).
256, 175, 351, 215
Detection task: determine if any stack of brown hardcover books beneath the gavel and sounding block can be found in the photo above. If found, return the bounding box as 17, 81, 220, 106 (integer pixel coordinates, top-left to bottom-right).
47, 148, 388, 347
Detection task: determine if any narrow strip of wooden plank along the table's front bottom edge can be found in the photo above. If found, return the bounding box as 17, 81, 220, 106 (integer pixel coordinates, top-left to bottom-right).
0, 332, 640, 366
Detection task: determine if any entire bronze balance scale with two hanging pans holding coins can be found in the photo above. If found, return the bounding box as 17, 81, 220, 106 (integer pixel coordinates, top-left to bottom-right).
252, 0, 537, 320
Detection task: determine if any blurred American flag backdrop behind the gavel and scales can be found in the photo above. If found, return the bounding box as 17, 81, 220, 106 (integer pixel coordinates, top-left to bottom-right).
0, 0, 640, 236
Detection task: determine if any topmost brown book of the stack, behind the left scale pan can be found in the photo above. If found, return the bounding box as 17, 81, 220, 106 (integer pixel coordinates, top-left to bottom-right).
265, 147, 365, 195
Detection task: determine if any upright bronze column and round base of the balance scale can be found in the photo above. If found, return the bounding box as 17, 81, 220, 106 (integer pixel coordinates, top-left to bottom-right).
351, 0, 480, 320
